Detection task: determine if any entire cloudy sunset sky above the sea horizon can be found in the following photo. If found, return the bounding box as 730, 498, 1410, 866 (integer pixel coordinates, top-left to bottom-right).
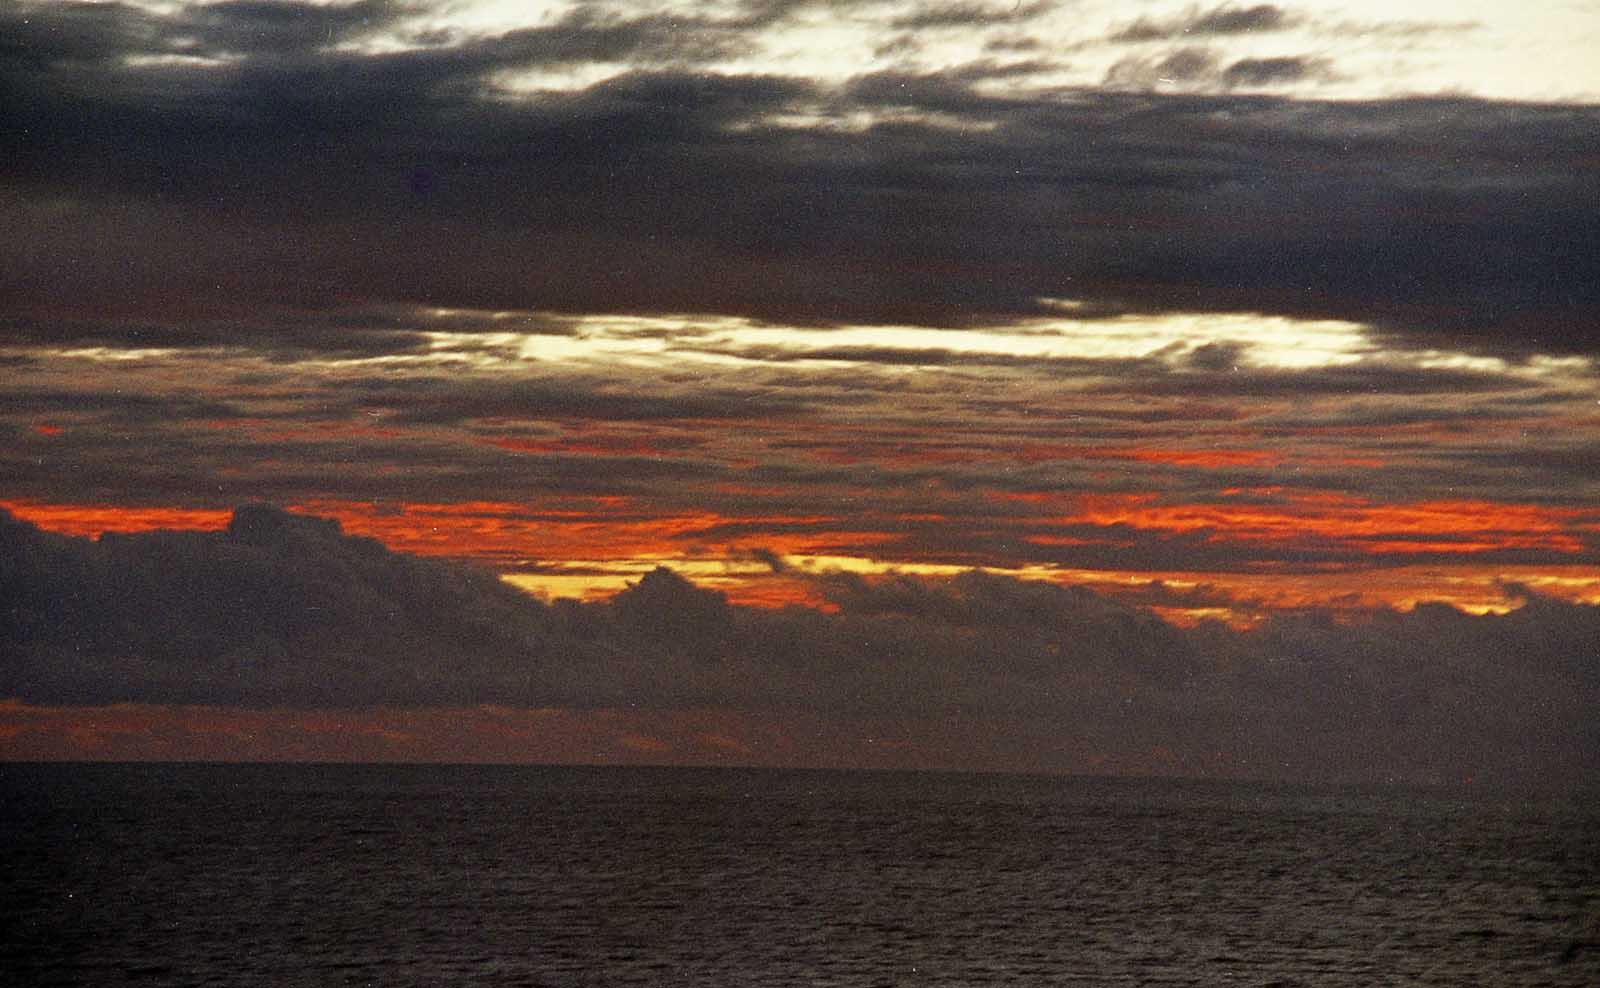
0, 0, 1600, 787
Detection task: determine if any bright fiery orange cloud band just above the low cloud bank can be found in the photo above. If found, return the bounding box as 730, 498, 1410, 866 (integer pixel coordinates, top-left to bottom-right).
12, 484, 1600, 623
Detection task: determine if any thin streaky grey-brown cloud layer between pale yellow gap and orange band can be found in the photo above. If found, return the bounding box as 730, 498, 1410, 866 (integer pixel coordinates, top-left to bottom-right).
9, 332, 1595, 517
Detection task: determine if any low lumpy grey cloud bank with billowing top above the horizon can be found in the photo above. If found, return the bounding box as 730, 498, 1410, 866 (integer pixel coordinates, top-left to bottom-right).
0, 507, 1600, 783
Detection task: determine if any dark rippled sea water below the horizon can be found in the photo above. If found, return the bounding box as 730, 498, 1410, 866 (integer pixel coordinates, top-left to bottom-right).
0, 764, 1600, 988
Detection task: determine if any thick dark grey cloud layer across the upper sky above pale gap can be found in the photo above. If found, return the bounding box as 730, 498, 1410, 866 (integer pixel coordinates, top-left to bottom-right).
0, 3, 1600, 353
